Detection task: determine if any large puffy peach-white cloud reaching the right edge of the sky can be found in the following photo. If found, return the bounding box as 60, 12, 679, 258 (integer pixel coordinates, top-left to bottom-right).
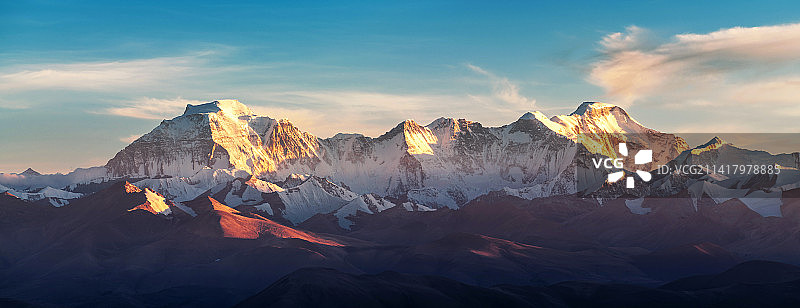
589, 24, 800, 105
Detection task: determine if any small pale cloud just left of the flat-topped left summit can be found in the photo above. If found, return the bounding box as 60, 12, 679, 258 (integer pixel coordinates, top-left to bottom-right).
97, 97, 205, 120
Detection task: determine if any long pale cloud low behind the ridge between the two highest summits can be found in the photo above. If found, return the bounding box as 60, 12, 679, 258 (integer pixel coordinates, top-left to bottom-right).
247, 91, 496, 137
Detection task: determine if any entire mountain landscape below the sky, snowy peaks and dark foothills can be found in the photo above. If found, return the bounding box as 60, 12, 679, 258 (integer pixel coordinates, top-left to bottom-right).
0, 100, 800, 307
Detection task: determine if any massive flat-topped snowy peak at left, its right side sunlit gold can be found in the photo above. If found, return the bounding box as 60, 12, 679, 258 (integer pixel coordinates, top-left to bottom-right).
106, 100, 284, 178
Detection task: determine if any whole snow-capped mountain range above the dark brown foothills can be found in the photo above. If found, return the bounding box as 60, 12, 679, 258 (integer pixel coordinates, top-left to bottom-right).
0, 100, 800, 228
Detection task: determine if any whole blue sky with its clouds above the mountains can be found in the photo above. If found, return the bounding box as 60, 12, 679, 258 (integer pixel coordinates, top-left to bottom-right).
0, 1, 800, 173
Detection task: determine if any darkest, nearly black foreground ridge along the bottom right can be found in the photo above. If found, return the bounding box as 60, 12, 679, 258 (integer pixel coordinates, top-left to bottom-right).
235, 261, 800, 307
